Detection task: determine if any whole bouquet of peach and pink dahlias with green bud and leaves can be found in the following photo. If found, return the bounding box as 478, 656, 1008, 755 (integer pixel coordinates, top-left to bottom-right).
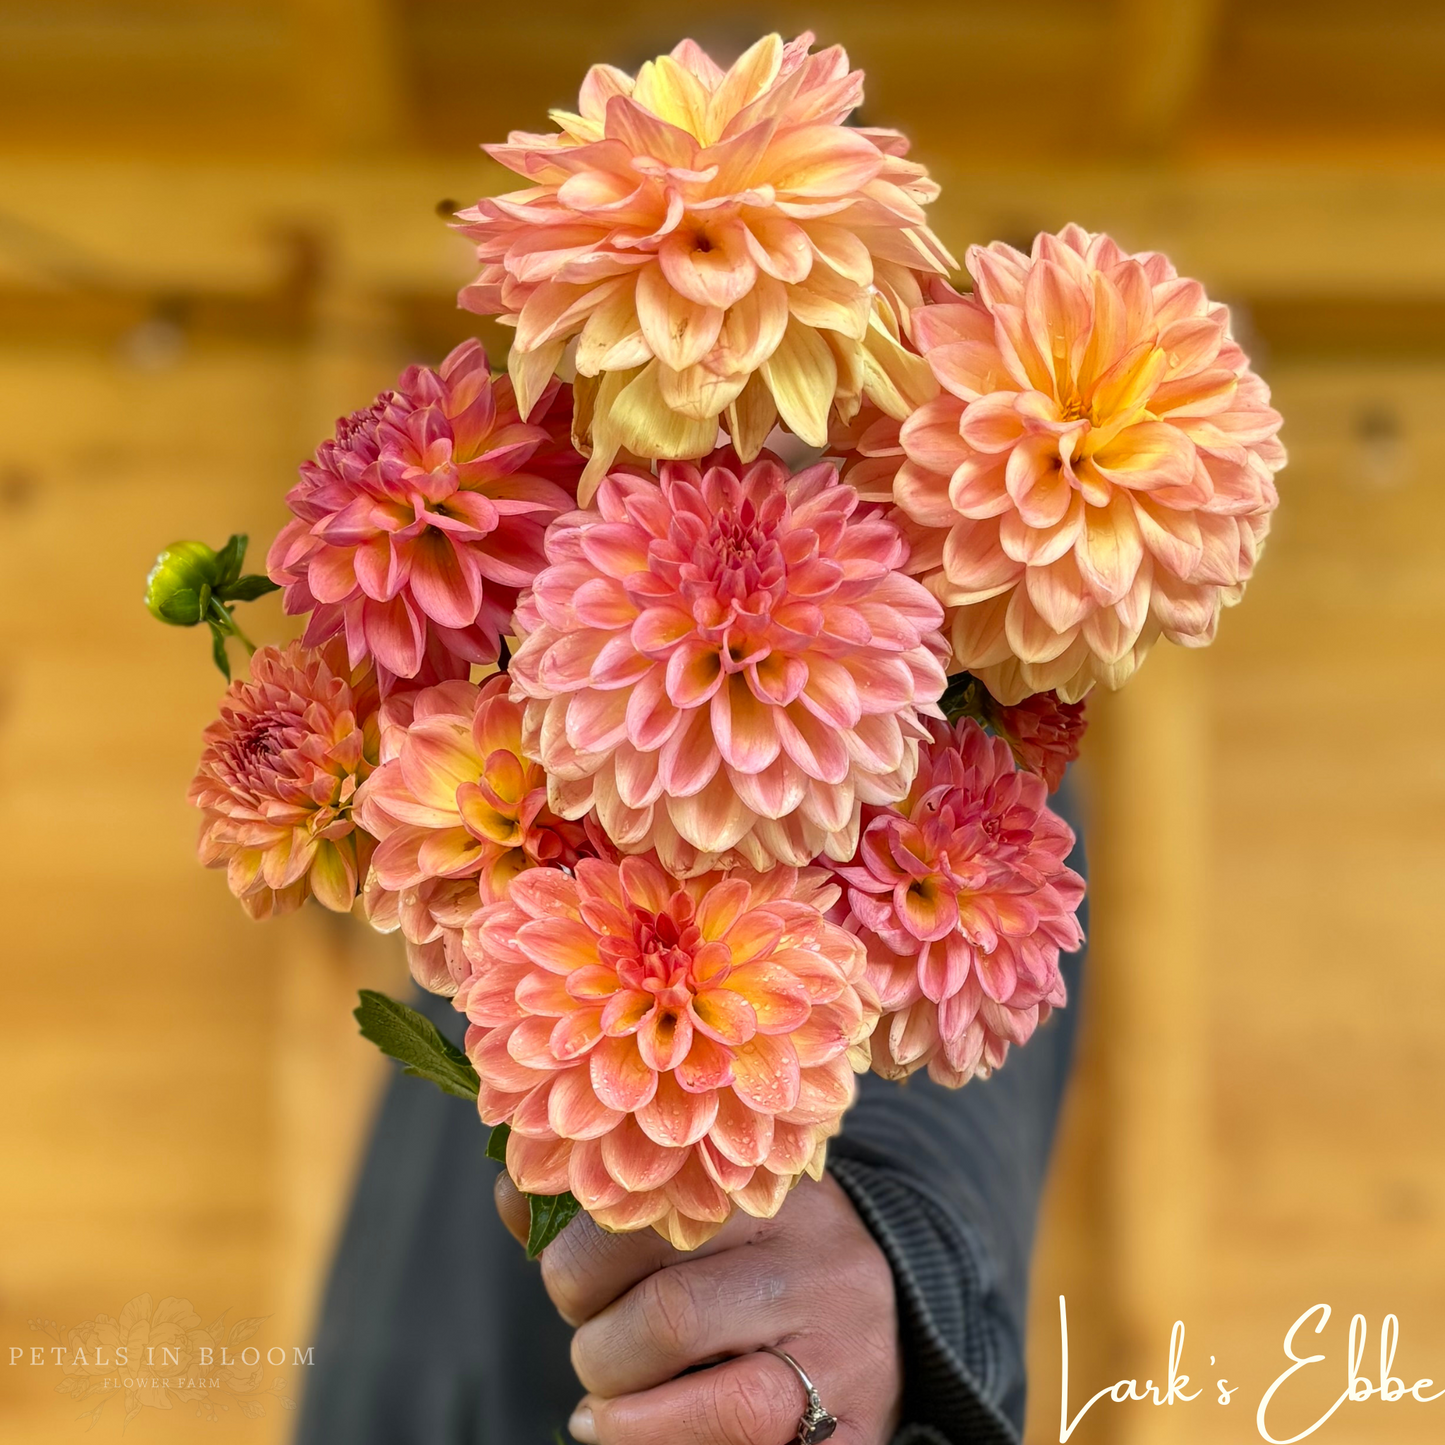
147, 35, 1285, 1253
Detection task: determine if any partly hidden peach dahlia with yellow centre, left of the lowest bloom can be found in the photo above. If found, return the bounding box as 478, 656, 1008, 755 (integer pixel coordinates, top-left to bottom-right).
358, 675, 595, 994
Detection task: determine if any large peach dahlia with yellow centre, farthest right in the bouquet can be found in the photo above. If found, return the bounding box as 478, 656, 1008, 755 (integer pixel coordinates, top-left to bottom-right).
894, 225, 1285, 702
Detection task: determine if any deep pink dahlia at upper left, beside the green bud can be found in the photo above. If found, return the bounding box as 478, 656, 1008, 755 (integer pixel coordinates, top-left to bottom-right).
267, 341, 581, 691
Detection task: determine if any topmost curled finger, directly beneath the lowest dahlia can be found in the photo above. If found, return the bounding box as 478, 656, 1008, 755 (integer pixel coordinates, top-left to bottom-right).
542, 1211, 772, 1325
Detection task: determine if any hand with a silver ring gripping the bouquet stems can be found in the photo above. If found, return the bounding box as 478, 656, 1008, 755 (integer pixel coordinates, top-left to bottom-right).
497, 1173, 903, 1445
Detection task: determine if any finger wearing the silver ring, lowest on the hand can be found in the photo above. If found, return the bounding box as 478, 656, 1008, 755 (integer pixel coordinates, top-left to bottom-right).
584, 1354, 808, 1445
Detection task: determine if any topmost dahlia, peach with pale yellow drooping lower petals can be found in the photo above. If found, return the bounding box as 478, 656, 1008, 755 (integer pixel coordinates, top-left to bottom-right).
461, 35, 954, 501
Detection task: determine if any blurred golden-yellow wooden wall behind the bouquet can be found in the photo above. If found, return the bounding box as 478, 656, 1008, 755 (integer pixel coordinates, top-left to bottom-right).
0, 0, 1445, 1445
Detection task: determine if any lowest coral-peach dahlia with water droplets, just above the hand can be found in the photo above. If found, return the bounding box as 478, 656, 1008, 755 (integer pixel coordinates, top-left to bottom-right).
457, 858, 877, 1250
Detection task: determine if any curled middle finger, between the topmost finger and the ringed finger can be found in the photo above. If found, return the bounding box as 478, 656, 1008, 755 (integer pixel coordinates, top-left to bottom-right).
572, 1247, 809, 1396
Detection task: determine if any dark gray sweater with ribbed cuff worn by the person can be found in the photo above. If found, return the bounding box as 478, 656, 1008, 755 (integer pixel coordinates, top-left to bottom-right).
296, 788, 1084, 1445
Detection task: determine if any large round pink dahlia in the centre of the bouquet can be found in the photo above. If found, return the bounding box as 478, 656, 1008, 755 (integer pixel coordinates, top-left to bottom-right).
512, 454, 948, 877
